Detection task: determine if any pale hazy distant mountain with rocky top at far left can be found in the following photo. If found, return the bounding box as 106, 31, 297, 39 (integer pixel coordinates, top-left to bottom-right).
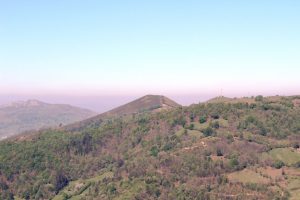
0, 100, 96, 139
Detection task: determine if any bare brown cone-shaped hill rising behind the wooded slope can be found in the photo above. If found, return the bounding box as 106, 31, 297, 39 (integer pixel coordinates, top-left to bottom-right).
65, 95, 181, 131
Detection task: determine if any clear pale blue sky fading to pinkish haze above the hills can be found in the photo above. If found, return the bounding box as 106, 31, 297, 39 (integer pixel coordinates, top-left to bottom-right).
0, 0, 300, 110
